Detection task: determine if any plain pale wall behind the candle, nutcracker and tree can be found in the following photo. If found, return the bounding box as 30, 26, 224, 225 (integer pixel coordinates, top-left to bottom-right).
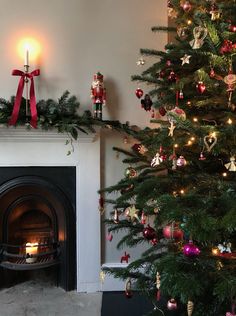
0, 0, 167, 262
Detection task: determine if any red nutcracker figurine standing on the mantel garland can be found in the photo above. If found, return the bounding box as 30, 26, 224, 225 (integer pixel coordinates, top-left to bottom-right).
91, 72, 106, 120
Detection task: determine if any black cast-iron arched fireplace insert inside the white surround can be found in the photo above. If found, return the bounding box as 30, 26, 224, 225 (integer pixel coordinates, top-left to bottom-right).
0, 166, 76, 291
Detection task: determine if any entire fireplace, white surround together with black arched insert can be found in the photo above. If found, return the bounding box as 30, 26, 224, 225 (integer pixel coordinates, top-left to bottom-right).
0, 128, 101, 292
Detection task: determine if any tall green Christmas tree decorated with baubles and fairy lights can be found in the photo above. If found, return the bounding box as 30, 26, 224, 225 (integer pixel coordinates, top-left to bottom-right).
104, 0, 236, 316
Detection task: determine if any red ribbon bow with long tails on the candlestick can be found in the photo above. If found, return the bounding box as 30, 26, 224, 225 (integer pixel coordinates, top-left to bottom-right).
8, 69, 40, 128
